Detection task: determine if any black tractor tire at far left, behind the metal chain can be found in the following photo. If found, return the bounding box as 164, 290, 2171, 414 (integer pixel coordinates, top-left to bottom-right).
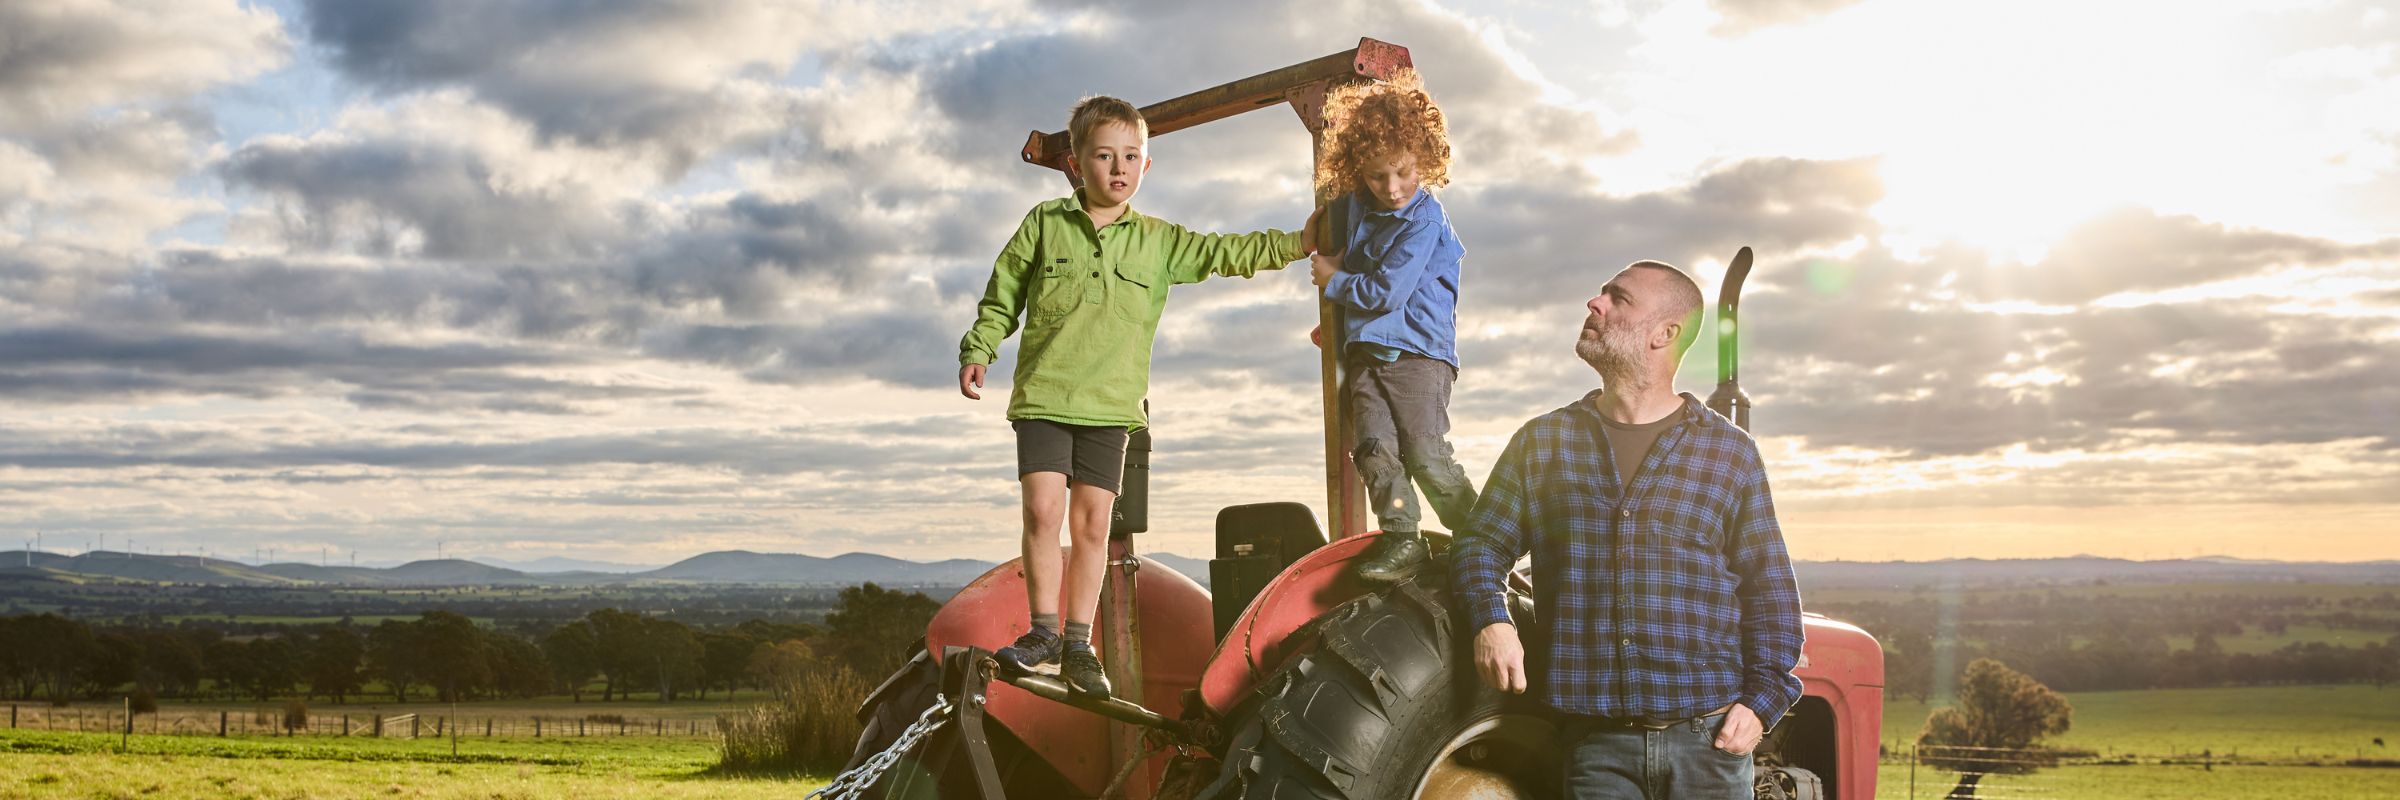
842, 646, 1075, 800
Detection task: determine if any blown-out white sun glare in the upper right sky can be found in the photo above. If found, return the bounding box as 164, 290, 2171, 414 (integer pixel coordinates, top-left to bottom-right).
1603, 0, 2390, 262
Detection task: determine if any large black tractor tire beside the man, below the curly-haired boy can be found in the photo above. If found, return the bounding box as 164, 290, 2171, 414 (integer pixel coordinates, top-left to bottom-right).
1200, 565, 1560, 800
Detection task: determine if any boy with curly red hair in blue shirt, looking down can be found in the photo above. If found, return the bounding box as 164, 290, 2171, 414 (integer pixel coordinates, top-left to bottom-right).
1310, 70, 1476, 584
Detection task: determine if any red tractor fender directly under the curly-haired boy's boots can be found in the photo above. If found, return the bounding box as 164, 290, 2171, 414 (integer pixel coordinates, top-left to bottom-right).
1200, 531, 1392, 716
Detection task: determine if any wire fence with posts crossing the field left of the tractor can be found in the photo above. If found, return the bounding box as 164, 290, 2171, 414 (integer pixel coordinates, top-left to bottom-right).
7, 704, 718, 738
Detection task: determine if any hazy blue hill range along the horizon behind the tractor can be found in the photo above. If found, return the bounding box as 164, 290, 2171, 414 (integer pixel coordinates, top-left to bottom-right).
0, 550, 2400, 589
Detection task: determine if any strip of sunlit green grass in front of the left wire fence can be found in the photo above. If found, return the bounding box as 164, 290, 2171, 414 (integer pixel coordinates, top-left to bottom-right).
0, 730, 823, 800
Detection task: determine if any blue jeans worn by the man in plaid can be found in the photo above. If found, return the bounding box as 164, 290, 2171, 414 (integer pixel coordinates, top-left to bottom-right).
1560, 714, 1752, 800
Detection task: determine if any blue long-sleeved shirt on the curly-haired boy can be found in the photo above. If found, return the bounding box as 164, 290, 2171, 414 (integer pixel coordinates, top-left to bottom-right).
1325, 190, 1466, 368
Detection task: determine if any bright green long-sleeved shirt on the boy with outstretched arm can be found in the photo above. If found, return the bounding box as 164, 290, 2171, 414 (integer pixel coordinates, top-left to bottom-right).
958, 192, 1308, 428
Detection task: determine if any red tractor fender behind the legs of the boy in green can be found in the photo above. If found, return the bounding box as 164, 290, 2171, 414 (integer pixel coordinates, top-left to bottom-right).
924, 557, 1212, 798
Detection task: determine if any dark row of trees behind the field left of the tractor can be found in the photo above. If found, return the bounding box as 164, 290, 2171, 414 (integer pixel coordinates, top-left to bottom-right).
0, 584, 938, 702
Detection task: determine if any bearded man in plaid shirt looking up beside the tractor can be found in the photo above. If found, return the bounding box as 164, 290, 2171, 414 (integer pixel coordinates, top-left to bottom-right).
1452, 262, 1800, 800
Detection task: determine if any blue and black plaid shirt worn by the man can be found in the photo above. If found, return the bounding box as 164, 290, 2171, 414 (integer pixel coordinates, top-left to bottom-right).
1452, 392, 1800, 726
